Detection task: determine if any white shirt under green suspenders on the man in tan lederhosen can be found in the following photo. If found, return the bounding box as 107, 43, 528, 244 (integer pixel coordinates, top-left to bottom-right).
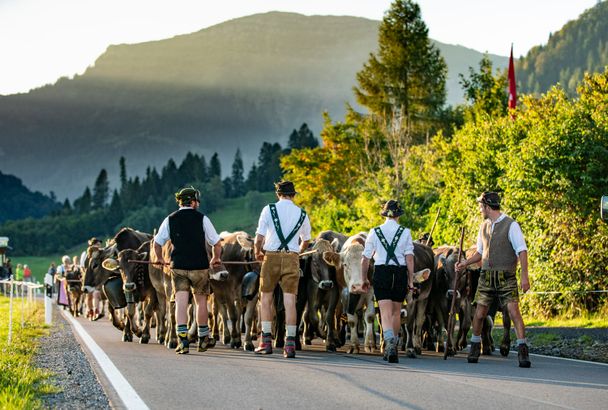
256, 199, 311, 252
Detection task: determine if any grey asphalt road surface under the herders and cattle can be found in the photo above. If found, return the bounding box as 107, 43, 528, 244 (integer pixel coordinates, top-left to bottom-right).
64, 310, 608, 410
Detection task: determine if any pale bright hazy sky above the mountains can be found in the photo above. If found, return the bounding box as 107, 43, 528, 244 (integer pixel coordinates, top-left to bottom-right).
0, 0, 597, 94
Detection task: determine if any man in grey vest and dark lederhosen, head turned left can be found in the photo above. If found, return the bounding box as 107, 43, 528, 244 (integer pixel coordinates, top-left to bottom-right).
456, 192, 530, 367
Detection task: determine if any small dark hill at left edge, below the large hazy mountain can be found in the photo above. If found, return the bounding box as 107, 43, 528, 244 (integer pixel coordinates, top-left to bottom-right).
0, 172, 61, 224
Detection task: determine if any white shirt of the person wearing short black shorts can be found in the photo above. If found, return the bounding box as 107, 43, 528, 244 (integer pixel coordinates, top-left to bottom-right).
363, 219, 414, 266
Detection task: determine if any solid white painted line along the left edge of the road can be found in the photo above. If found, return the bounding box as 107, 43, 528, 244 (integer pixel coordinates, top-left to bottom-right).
61, 312, 149, 410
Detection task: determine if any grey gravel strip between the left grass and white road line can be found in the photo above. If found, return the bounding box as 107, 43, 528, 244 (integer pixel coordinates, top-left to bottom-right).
34, 308, 111, 409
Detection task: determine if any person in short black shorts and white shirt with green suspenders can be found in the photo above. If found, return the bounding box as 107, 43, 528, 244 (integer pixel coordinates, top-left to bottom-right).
361, 199, 414, 363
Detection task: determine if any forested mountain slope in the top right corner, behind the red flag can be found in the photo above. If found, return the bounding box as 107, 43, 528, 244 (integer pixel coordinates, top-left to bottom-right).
516, 1, 608, 95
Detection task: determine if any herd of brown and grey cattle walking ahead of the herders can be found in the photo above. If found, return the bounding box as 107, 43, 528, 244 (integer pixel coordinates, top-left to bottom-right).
70, 228, 510, 357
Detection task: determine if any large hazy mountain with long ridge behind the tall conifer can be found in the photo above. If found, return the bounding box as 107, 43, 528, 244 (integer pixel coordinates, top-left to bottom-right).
0, 12, 507, 198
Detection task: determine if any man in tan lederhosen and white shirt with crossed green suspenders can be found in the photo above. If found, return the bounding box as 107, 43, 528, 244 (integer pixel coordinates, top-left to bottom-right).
255, 181, 310, 358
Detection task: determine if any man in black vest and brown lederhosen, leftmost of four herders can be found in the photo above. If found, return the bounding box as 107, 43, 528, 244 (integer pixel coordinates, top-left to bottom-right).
154, 187, 222, 354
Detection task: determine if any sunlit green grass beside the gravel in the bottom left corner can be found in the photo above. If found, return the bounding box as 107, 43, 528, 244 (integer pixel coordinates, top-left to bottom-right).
0, 296, 56, 409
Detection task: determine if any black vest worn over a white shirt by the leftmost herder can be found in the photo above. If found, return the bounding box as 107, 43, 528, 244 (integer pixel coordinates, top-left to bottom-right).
169, 209, 209, 270
